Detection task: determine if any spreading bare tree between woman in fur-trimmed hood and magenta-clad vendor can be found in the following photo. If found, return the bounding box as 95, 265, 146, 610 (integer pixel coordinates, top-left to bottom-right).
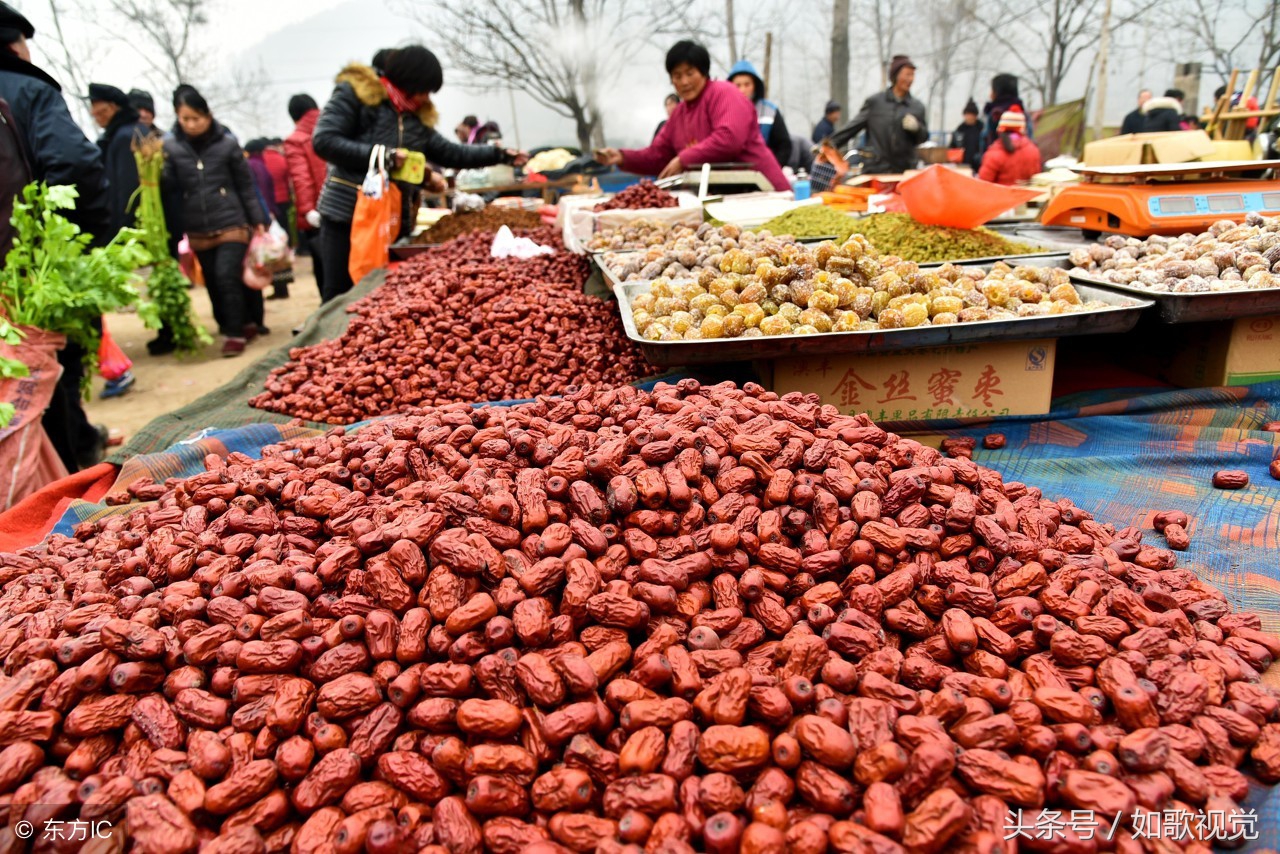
403, 0, 699, 150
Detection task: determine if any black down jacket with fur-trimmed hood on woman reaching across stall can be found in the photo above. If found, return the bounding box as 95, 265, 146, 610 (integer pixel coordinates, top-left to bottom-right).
311, 64, 507, 224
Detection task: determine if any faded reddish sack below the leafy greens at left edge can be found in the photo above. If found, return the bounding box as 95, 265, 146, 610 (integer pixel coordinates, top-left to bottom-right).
0, 326, 67, 510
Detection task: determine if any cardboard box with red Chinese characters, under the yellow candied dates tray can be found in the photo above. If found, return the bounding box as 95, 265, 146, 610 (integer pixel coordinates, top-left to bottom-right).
772, 339, 1057, 421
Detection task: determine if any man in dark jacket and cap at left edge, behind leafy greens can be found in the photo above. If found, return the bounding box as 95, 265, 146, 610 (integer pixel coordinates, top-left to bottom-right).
0, 3, 110, 471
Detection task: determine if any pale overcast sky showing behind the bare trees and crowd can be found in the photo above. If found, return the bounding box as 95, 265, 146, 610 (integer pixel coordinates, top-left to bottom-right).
17, 0, 1259, 149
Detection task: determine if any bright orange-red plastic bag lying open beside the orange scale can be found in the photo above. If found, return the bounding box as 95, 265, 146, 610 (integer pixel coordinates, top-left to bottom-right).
897, 164, 1042, 228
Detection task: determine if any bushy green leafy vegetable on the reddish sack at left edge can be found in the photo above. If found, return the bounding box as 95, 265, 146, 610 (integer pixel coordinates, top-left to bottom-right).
0, 183, 160, 393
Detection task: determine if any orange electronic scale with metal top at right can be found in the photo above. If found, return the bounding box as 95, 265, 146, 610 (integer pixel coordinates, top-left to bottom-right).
1041, 160, 1280, 237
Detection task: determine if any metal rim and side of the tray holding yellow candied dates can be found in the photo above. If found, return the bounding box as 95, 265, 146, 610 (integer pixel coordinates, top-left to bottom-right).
613, 277, 1155, 367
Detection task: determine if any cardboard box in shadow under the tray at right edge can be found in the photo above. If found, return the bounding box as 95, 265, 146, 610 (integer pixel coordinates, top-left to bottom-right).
1165, 315, 1280, 388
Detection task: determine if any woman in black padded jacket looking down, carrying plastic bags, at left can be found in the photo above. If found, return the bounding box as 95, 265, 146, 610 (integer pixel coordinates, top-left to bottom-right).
164, 86, 270, 356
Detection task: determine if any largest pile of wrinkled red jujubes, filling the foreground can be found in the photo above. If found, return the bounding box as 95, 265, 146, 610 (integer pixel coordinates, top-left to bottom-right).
0, 379, 1280, 854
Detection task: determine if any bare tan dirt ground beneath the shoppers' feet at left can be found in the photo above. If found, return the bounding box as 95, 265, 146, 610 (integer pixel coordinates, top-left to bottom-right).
84, 257, 320, 438
